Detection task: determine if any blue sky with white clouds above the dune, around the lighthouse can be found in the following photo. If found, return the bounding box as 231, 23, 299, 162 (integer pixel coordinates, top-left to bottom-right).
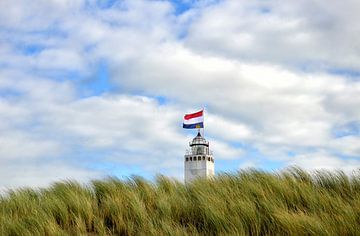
0, 0, 360, 190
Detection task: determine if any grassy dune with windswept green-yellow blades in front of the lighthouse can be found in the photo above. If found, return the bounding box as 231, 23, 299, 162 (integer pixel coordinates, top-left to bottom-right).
0, 168, 360, 235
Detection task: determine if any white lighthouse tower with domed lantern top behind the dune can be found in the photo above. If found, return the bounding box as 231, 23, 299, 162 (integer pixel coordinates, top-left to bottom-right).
184, 131, 215, 183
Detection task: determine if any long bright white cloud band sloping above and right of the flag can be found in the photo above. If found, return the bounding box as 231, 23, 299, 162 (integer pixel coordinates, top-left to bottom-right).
107, 41, 359, 151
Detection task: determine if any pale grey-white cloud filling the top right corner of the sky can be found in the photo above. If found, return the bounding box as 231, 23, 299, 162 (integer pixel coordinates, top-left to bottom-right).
185, 0, 360, 71
